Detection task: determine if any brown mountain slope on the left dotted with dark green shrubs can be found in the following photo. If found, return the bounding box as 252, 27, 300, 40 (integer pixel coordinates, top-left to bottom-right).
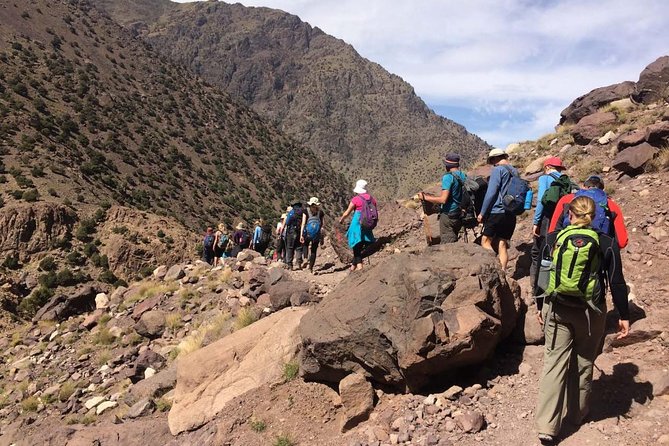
0, 0, 348, 225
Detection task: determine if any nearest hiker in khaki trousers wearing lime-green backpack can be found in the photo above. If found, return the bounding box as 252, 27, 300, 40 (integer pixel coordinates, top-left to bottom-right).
536, 196, 629, 444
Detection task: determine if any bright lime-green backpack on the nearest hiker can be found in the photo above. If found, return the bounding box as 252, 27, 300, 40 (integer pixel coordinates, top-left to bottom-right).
546, 226, 602, 313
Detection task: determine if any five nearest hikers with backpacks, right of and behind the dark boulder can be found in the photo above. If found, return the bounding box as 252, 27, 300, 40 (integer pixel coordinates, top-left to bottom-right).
419, 149, 630, 444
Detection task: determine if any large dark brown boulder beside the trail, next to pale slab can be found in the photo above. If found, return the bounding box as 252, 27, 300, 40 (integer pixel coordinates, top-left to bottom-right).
300, 243, 520, 391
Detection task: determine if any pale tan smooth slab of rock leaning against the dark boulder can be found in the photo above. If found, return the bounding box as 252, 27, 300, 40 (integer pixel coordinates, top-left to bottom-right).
167, 308, 308, 435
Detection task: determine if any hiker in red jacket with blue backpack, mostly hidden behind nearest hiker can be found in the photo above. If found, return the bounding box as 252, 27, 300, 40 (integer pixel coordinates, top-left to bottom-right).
549, 175, 629, 249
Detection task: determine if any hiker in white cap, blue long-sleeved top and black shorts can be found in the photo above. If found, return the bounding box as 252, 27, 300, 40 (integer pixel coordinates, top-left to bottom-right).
477, 149, 518, 270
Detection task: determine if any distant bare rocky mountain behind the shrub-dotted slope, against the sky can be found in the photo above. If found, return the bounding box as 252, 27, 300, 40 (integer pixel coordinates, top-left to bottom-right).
95, 0, 490, 198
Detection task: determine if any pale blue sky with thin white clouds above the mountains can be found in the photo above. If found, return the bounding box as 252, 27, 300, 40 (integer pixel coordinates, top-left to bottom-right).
174, 0, 669, 148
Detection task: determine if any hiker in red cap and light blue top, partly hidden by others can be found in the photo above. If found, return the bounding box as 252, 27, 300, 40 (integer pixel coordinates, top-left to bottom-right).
530, 156, 566, 296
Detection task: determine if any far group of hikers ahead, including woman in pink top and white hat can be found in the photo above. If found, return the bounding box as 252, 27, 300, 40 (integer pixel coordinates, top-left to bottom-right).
202, 180, 378, 274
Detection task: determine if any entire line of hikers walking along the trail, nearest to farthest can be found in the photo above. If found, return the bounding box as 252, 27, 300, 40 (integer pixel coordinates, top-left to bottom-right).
198, 149, 630, 444
